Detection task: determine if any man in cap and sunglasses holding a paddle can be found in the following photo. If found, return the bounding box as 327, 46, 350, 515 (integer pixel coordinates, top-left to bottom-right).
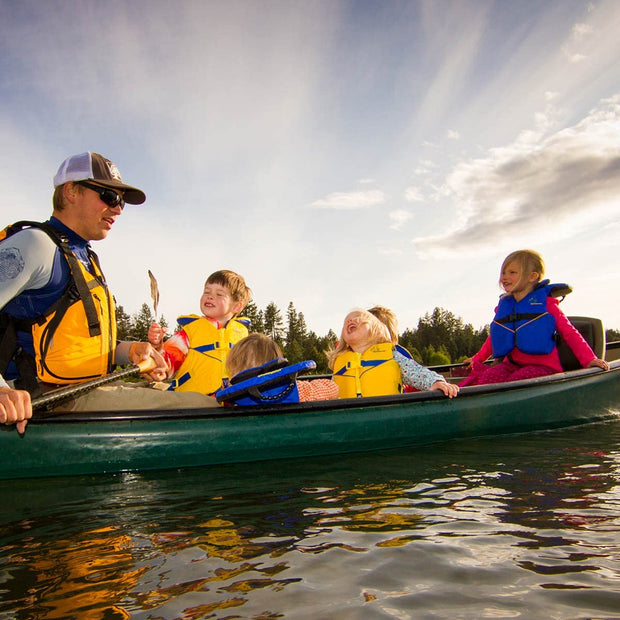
0, 152, 211, 432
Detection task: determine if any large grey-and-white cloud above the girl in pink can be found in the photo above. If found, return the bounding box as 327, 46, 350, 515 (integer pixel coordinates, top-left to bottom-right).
415, 95, 620, 254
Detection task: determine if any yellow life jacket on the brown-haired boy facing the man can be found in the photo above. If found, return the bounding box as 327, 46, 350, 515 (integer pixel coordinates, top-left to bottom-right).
171, 314, 249, 394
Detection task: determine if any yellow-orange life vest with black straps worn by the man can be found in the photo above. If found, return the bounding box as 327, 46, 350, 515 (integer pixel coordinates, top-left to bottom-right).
1, 222, 116, 384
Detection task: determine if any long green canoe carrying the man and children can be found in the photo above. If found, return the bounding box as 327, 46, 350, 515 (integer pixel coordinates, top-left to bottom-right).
0, 352, 620, 478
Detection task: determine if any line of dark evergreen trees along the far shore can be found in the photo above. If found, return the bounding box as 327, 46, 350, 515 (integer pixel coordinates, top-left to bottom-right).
116, 301, 620, 374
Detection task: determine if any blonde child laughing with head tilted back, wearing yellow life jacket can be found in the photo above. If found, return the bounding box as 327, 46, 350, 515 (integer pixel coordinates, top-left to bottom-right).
329, 309, 459, 398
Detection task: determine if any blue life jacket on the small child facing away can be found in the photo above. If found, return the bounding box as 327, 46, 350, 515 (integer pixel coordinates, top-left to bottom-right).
215, 357, 316, 405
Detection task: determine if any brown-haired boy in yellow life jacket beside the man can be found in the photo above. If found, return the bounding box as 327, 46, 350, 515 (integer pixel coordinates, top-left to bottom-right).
148, 270, 252, 395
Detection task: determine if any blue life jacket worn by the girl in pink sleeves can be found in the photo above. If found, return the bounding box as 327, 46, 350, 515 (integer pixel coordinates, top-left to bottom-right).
489, 280, 572, 357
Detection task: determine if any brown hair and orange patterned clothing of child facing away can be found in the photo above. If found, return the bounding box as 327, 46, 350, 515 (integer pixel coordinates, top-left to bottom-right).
226, 333, 338, 402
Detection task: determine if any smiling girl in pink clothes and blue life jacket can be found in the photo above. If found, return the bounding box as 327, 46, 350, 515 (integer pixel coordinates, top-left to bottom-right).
460, 250, 609, 386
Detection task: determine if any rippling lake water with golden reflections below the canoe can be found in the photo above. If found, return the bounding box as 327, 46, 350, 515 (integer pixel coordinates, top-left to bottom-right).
0, 421, 620, 620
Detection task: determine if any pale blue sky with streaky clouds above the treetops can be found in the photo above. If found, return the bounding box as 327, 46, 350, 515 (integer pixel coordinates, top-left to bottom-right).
0, 0, 620, 336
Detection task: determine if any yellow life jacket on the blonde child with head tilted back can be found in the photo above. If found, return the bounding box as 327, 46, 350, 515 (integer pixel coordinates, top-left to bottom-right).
333, 342, 403, 398
